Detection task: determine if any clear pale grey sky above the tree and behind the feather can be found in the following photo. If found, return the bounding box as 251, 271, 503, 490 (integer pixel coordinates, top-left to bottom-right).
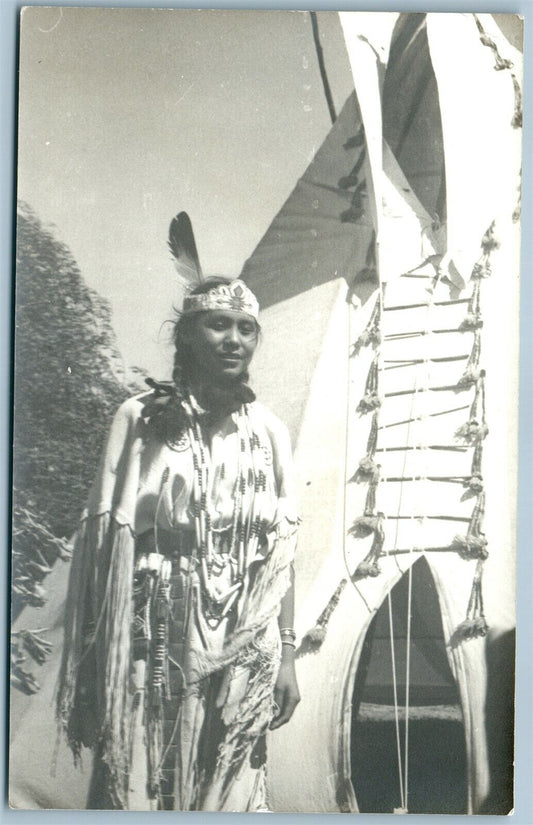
18, 7, 353, 377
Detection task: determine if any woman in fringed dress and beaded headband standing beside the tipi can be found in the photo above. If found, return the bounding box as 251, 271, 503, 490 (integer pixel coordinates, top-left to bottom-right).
57, 278, 299, 811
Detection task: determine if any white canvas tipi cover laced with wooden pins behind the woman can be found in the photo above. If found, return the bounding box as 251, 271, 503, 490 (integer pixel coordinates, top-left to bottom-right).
244, 13, 520, 813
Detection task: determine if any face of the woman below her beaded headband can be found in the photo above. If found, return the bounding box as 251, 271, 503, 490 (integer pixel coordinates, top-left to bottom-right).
187, 310, 258, 383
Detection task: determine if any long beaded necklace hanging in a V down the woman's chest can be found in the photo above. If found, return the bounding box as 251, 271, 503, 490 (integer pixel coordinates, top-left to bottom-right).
182, 395, 268, 625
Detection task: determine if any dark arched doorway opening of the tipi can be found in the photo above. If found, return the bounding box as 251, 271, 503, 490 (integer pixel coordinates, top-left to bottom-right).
351, 557, 466, 813
